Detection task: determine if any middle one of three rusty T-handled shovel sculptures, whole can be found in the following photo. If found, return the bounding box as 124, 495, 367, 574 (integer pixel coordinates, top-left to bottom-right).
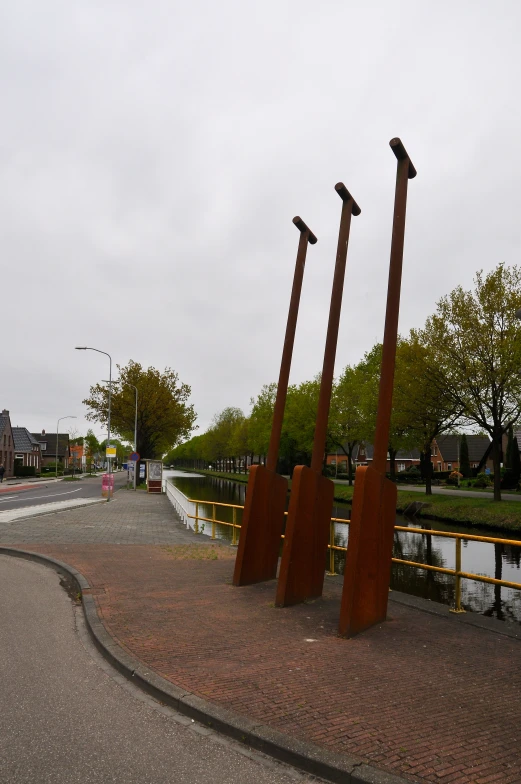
275, 187, 360, 607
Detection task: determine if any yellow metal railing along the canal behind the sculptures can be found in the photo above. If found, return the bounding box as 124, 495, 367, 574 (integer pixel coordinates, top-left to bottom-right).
186, 498, 521, 613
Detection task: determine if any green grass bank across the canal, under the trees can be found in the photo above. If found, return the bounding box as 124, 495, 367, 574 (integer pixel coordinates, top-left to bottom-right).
335, 485, 521, 531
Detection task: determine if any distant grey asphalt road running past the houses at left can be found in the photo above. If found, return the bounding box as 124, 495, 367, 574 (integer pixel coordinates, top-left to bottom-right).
0, 471, 127, 512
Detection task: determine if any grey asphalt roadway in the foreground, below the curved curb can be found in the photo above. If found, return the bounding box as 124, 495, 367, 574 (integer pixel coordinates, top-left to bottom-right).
0, 556, 310, 784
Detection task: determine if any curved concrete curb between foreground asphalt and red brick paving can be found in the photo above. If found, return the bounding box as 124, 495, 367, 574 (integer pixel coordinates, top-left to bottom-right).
0, 546, 414, 784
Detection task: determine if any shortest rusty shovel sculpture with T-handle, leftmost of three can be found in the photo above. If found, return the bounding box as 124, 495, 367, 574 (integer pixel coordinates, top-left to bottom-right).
233, 216, 317, 585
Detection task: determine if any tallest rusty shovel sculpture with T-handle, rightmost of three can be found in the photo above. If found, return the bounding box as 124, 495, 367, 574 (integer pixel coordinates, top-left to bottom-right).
339, 139, 416, 637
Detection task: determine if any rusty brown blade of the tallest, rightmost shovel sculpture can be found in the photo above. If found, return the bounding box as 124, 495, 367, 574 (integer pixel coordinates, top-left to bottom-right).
338, 466, 397, 637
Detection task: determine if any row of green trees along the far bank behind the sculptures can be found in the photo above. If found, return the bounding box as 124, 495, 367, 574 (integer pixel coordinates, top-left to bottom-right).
166, 264, 521, 500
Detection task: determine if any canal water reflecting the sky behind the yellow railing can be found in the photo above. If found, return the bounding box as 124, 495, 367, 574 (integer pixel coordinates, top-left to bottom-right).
164, 471, 521, 623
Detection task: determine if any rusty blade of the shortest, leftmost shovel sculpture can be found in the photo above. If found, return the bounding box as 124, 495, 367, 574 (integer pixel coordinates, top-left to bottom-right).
233, 465, 288, 586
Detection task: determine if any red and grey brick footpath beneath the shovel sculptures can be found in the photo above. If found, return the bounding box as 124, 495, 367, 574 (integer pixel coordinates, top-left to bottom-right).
0, 490, 521, 784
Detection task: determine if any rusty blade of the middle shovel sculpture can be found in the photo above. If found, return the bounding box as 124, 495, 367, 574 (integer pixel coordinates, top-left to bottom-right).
275, 466, 335, 607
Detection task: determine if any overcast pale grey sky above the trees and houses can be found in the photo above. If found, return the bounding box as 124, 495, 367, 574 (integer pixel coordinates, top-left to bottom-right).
0, 0, 521, 440
